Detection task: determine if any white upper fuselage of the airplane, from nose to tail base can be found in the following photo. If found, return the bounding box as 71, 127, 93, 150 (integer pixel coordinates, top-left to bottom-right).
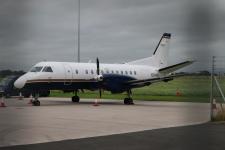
14, 62, 158, 88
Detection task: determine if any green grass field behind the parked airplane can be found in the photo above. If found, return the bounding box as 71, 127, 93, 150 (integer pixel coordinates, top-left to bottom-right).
51, 76, 216, 102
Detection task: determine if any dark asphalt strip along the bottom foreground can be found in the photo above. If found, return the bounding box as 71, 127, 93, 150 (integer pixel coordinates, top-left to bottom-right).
0, 123, 225, 150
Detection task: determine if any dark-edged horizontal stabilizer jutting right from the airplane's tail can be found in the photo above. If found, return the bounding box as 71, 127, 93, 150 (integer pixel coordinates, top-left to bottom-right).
159, 61, 194, 74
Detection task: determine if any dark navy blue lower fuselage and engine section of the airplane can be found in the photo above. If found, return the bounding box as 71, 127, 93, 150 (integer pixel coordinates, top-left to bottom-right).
25, 74, 135, 93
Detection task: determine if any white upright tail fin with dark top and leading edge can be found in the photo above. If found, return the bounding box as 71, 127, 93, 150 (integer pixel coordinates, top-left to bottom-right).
128, 33, 171, 68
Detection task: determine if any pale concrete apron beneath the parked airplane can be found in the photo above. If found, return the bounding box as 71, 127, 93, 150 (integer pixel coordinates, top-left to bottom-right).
0, 98, 210, 149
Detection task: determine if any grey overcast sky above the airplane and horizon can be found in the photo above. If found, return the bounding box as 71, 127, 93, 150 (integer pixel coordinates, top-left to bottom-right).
0, 0, 225, 71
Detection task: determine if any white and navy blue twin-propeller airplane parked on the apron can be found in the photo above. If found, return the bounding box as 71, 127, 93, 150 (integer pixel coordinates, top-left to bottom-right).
14, 33, 194, 106
